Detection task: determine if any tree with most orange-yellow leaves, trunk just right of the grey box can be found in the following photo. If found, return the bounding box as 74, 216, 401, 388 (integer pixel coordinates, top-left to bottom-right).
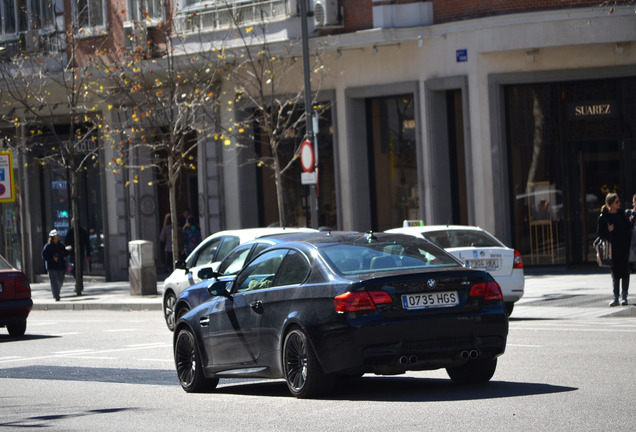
93, 10, 225, 266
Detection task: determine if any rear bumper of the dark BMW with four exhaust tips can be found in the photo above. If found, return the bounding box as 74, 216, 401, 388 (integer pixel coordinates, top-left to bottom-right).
315, 308, 508, 374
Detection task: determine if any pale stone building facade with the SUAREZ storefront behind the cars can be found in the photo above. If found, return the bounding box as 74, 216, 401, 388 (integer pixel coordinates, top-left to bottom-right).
0, 0, 636, 280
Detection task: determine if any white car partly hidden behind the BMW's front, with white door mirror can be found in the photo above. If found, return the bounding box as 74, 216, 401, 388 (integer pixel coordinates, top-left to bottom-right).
163, 228, 317, 330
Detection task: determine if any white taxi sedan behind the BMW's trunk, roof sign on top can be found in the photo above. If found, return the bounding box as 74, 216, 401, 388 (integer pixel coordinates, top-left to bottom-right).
386, 223, 525, 315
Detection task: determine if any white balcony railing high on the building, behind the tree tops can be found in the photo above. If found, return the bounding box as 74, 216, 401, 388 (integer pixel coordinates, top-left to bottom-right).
175, 0, 297, 33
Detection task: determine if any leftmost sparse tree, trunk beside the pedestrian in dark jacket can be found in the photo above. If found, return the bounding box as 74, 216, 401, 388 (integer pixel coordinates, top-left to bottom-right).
0, 3, 102, 293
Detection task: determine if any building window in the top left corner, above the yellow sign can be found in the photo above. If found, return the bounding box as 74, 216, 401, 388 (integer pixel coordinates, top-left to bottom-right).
0, 0, 53, 36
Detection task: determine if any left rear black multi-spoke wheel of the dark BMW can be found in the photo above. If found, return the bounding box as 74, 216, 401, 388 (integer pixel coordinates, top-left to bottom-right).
283, 328, 333, 398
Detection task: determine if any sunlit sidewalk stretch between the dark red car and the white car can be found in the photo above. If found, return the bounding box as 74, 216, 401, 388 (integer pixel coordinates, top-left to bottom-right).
31, 275, 163, 310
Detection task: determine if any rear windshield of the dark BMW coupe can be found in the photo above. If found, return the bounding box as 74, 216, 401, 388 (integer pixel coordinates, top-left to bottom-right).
321, 241, 461, 275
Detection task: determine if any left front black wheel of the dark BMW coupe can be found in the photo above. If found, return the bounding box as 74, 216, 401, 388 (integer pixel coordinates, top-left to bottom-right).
174, 329, 219, 393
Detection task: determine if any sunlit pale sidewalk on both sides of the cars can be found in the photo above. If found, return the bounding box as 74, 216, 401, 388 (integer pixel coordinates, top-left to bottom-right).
31, 267, 636, 319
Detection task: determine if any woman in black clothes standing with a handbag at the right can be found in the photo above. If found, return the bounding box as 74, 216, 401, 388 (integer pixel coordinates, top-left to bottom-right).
596, 193, 631, 307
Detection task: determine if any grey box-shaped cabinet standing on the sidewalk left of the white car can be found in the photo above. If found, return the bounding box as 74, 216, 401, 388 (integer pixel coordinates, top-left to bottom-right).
128, 240, 157, 295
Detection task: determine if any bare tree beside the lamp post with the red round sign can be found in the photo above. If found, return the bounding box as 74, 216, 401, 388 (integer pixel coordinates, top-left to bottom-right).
219, 3, 328, 226
